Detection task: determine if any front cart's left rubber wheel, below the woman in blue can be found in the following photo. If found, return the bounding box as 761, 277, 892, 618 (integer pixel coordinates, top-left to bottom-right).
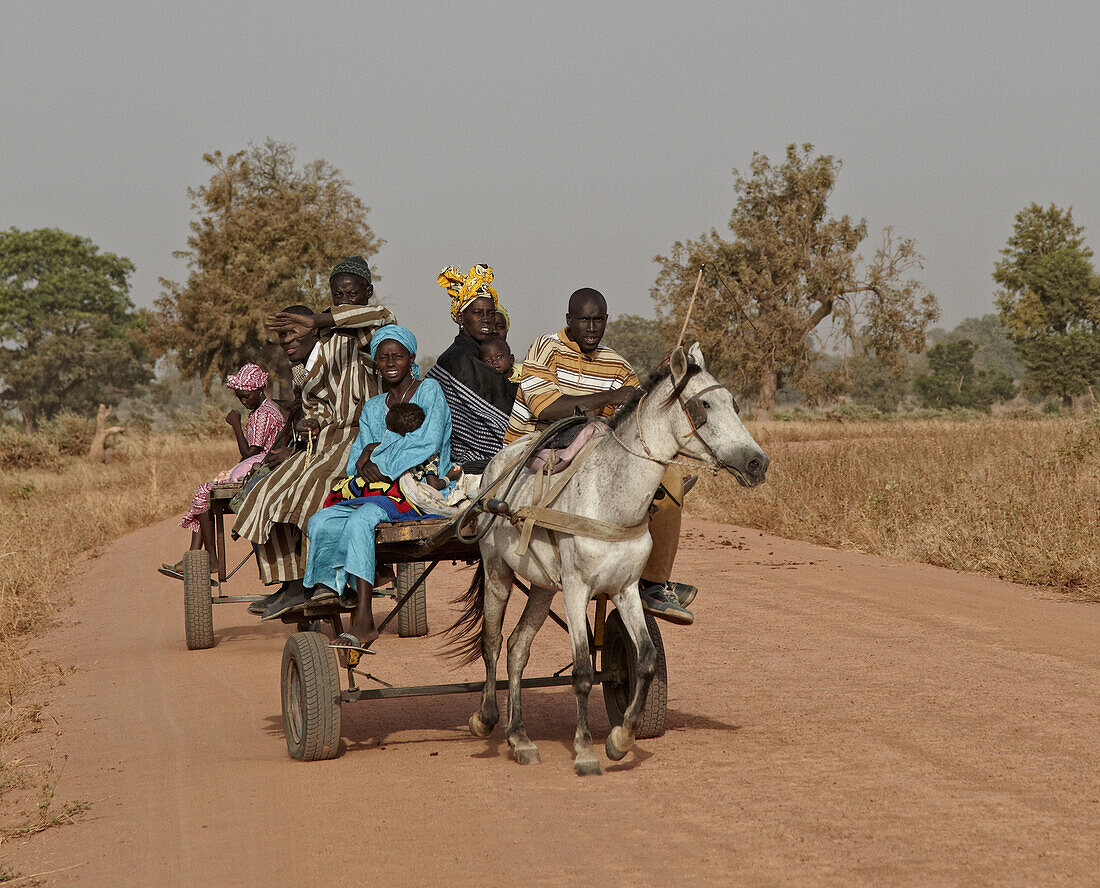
283, 632, 340, 761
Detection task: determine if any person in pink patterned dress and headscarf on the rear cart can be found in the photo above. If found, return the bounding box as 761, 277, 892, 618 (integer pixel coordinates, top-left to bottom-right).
160, 364, 286, 579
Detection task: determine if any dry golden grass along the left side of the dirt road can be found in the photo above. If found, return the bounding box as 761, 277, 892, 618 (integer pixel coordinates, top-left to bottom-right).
0, 436, 237, 721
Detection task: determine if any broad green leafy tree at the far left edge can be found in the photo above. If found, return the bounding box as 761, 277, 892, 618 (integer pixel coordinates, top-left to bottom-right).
0, 228, 153, 430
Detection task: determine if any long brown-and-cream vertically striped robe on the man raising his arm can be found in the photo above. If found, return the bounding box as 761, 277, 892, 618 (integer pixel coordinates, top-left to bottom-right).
233, 305, 397, 585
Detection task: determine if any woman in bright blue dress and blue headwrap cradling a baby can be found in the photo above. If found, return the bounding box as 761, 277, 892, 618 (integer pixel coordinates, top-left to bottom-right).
305, 325, 451, 646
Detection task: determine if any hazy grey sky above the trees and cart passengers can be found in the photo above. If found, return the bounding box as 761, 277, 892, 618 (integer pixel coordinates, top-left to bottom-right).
0, 0, 1100, 353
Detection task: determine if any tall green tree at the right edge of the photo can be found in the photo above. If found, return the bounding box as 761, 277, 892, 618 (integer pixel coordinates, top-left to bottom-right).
993, 204, 1100, 407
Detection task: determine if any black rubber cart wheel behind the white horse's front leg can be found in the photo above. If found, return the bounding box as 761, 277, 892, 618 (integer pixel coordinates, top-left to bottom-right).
600, 611, 669, 739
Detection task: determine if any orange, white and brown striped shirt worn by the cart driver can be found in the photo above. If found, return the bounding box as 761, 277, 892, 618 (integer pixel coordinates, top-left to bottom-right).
504, 329, 638, 445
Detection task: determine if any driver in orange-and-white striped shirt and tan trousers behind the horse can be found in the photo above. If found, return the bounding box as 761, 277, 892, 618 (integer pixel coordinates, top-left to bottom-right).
504, 287, 696, 625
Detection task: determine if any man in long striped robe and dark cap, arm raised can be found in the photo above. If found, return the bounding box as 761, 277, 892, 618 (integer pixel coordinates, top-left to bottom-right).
233, 256, 396, 618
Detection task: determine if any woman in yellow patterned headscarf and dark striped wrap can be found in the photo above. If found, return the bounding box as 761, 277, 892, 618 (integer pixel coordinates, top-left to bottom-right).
428, 265, 513, 470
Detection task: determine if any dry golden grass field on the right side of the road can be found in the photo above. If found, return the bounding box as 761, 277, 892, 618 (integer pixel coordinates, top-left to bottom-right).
688, 414, 1100, 600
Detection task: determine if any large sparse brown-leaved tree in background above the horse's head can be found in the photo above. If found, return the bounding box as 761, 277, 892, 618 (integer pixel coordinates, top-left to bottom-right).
650, 144, 939, 417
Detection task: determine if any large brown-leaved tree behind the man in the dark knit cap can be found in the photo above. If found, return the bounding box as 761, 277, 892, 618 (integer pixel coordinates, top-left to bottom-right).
156, 139, 383, 391
